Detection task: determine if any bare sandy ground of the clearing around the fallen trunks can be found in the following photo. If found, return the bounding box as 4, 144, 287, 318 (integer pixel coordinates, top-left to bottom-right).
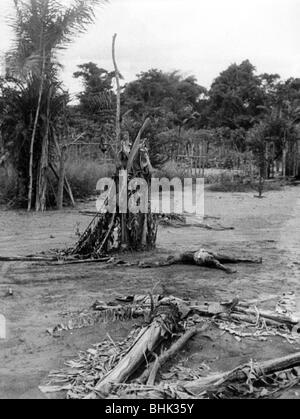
0, 186, 300, 398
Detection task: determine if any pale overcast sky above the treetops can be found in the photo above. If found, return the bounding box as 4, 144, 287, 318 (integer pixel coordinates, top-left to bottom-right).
0, 0, 300, 97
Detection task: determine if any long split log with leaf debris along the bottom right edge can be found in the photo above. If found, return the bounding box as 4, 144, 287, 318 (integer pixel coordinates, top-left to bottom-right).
110, 352, 300, 399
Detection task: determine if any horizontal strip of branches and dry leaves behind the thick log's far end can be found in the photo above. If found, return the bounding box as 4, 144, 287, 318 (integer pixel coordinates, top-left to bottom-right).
48, 294, 300, 343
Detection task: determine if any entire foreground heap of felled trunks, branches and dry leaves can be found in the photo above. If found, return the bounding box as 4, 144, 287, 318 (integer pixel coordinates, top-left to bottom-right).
41, 295, 300, 398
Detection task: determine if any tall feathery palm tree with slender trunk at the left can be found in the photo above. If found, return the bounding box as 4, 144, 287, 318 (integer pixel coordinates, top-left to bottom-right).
6, 0, 106, 210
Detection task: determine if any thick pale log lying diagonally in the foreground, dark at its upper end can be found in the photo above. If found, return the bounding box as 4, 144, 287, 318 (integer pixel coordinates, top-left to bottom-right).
95, 303, 180, 394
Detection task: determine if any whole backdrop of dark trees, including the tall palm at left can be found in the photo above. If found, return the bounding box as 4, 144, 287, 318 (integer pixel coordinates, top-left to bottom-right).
0, 0, 300, 210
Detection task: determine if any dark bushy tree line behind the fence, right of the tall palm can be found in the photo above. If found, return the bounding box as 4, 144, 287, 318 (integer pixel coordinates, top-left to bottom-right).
69, 61, 300, 176
